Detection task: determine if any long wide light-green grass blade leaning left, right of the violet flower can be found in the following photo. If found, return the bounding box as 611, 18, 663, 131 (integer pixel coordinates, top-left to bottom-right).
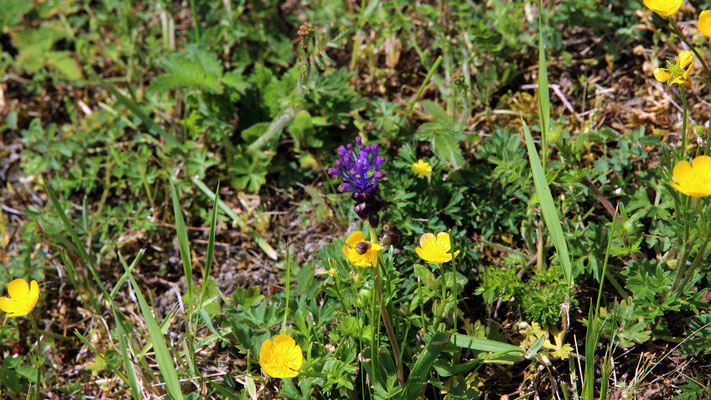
522, 119, 573, 286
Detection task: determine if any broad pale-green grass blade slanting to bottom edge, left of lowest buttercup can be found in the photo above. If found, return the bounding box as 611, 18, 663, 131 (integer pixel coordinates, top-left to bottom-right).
122, 262, 183, 400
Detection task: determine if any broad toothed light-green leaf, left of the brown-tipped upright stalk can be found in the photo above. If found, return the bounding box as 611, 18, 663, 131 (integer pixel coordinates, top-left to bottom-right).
148, 44, 222, 93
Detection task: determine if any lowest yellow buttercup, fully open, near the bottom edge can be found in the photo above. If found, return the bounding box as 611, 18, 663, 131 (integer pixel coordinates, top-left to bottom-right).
259, 335, 304, 378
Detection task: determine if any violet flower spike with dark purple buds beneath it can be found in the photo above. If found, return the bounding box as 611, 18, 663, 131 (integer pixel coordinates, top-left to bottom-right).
328, 137, 386, 227
